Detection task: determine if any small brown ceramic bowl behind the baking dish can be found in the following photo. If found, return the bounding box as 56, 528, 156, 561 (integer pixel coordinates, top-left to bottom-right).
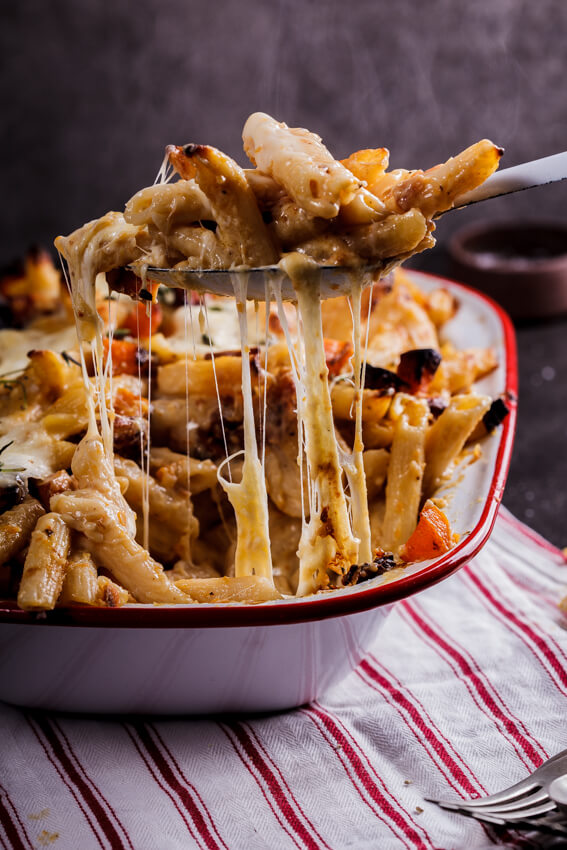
449, 222, 567, 320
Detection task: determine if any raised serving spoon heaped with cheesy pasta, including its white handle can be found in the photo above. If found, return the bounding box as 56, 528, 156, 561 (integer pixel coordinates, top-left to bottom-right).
56, 113, 567, 301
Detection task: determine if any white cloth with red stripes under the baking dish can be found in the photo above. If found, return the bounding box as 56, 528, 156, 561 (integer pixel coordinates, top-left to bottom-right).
0, 510, 567, 850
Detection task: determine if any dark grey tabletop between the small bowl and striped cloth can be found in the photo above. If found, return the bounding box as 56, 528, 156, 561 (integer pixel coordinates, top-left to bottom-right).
413, 249, 567, 548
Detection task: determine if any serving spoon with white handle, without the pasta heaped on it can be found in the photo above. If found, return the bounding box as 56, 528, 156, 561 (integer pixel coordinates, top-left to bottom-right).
131, 151, 567, 301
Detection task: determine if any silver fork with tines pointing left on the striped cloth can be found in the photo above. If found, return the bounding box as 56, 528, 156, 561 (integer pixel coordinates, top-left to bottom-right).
425, 750, 567, 837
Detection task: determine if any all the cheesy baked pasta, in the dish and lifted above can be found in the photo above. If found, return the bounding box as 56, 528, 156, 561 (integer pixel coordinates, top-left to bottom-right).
0, 113, 506, 611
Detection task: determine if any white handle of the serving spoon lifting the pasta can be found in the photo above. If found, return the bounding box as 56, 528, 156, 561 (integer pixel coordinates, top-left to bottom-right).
455, 152, 567, 209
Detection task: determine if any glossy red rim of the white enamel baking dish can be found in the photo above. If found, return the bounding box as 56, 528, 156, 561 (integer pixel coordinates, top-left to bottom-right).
0, 272, 518, 629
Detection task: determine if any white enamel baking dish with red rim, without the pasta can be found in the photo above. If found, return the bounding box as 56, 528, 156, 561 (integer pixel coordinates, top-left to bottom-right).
0, 272, 517, 714
